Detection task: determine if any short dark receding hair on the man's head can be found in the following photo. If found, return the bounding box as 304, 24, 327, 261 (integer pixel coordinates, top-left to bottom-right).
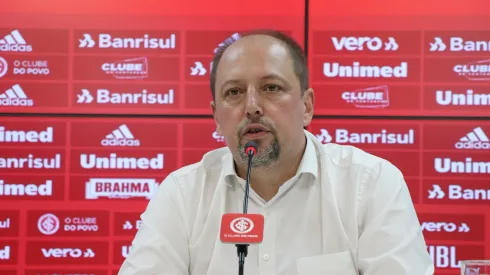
210, 29, 309, 101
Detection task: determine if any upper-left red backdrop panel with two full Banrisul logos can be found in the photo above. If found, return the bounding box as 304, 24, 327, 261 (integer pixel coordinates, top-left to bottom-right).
0, 0, 305, 115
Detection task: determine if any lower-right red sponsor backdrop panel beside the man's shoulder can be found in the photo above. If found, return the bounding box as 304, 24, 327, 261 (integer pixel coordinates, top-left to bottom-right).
309, 118, 490, 274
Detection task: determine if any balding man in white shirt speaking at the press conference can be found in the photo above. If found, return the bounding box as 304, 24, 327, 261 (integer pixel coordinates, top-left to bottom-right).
119, 31, 434, 275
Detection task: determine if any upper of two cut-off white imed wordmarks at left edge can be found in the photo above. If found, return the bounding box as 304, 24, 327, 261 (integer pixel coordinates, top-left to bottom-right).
0, 126, 53, 143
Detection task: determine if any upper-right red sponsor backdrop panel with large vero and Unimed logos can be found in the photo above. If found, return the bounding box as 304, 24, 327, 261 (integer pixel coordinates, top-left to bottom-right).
308, 0, 490, 117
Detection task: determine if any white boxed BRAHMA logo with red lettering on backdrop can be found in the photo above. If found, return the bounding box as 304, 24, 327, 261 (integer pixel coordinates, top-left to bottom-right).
85, 178, 158, 200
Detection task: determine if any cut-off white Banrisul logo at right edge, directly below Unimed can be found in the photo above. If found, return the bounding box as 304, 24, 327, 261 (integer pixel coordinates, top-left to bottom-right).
428, 184, 490, 201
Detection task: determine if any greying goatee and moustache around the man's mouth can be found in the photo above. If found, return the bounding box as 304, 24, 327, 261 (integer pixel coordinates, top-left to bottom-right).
237, 118, 281, 168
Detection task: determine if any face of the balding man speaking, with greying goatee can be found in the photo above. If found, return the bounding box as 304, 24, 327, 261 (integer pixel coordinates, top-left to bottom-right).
211, 35, 313, 167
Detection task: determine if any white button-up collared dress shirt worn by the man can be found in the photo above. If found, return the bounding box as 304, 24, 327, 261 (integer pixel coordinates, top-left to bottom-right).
119, 131, 434, 275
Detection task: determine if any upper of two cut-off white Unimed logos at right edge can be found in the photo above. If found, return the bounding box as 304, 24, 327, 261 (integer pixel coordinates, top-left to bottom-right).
436, 89, 490, 106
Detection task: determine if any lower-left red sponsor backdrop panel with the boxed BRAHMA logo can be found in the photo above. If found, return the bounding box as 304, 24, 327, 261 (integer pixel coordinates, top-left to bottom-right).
0, 116, 225, 274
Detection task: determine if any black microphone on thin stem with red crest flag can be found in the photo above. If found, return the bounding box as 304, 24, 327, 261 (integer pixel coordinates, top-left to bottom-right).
220, 141, 264, 275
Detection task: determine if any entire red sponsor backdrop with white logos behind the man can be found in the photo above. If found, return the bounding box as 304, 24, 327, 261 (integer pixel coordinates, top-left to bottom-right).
0, 0, 490, 275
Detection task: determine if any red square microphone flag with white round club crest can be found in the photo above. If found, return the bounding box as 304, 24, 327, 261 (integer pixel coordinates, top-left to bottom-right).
220, 213, 264, 244
